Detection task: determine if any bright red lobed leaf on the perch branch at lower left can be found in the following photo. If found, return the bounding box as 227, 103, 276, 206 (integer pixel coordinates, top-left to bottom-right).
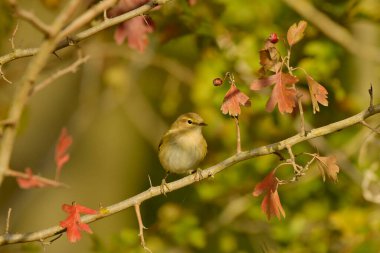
59, 203, 98, 243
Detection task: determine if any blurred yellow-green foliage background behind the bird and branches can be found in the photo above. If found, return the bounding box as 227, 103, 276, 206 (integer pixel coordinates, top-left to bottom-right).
0, 0, 380, 253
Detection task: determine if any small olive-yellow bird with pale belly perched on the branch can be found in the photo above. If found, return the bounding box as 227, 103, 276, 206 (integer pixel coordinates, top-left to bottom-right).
158, 112, 207, 192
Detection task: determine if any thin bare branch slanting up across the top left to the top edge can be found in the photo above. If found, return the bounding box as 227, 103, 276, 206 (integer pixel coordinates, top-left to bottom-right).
0, 0, 170, 65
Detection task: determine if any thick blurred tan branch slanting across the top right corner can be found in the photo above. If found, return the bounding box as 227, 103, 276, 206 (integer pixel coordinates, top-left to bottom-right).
282, 0, 380, 63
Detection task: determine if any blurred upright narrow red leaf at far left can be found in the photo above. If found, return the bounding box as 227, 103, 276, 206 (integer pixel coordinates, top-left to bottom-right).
55, 128, 73, 179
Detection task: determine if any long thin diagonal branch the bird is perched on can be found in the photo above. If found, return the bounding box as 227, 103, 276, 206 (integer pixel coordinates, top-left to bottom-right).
0, 104, 380, 245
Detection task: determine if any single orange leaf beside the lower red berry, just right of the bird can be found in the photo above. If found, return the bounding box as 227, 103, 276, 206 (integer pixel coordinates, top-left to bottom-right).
220, 84, 251, 117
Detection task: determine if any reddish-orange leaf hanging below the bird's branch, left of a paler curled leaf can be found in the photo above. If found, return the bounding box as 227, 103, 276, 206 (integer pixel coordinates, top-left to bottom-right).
252, 170, 285, 220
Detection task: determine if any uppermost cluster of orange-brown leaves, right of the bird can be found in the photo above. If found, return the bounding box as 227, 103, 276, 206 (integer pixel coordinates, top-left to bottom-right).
250, 21, 328, 113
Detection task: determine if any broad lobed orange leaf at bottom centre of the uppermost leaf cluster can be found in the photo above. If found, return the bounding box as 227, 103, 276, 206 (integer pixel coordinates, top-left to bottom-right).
250, 72, 298, 113
